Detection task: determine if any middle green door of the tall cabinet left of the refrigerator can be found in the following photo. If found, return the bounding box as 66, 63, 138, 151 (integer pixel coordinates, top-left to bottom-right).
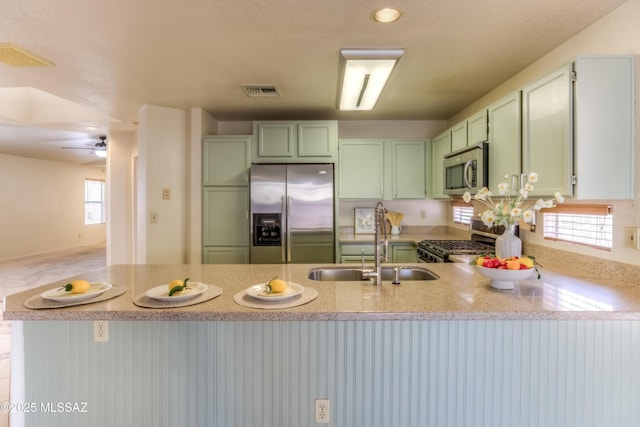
202, 187, 250, 247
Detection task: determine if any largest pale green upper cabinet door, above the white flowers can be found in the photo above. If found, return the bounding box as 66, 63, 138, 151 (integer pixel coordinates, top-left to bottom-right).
524, 65, 573, 196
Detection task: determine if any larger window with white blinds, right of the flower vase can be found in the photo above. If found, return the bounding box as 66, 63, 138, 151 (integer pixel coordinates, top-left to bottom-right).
542, 205, 613, 251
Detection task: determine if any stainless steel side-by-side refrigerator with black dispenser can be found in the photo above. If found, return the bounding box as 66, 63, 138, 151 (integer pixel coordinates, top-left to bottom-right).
251, 163, 335, 264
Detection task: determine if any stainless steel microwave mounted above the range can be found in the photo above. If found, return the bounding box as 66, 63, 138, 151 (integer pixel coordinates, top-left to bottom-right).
444, 142, 489, 195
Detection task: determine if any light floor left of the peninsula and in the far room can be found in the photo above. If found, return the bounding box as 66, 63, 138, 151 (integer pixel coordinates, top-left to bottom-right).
0, 243, 107, 427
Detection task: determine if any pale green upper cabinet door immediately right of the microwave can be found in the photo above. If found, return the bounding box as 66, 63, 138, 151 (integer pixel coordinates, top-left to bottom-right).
488, 91, 522, 190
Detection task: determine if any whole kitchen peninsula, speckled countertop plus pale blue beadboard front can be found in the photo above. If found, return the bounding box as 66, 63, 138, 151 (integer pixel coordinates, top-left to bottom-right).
5, 263, 640, 426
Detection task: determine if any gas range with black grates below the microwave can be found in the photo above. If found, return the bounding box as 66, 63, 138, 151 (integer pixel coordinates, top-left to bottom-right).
418, 219, 504, 262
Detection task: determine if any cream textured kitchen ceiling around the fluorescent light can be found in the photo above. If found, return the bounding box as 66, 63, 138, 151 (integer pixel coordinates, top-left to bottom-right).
0, 0, 623, 166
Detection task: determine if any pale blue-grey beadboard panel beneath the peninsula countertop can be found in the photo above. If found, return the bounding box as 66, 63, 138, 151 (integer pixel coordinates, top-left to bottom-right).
17, 320, 640, 427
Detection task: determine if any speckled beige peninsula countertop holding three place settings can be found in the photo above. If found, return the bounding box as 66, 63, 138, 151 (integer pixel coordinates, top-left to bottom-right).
4, 263, 640, 321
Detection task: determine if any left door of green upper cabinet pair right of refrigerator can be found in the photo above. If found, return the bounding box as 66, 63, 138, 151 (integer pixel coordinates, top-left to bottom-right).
338, 140, 384, 199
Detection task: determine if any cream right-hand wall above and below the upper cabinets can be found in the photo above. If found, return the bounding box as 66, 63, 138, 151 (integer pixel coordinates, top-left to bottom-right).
448, 0, 640, 265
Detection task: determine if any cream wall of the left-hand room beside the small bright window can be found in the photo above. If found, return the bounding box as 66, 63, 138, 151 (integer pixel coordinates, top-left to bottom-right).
0, 154, 106, 259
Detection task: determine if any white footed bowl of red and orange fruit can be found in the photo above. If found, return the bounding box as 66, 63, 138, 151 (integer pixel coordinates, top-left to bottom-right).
471, 255, 536, 289
